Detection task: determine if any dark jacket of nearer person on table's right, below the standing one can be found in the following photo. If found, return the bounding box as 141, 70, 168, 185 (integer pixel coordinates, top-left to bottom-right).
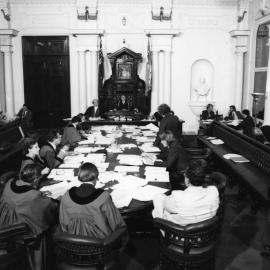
155, 141, 188, 173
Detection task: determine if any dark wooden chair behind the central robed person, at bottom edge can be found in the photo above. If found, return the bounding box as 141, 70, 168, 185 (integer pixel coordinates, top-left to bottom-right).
54, 228, 127, 270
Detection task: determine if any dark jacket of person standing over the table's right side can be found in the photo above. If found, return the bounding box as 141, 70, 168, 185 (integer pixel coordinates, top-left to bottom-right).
154, 114, 181, 146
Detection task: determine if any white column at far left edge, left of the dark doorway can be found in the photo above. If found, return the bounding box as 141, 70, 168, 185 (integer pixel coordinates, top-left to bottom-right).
1, 46, 15, 117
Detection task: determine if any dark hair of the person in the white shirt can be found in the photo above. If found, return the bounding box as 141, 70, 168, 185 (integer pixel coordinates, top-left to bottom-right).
186, 160, 206, 186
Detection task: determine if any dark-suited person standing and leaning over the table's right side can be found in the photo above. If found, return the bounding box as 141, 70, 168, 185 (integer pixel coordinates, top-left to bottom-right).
154, 104, 181, 148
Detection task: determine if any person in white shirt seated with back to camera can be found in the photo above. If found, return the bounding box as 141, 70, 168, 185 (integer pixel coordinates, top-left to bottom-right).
153, 161, 219, 226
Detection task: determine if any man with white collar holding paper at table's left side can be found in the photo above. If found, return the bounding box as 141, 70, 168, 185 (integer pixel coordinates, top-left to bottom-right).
39, 130, 69, 169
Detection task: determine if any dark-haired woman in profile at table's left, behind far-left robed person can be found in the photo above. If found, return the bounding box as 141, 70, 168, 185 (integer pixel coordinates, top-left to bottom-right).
21, 138, 50, 175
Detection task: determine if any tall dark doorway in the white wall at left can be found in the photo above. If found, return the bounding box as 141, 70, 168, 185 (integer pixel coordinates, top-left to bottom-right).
22, 36, 70, 128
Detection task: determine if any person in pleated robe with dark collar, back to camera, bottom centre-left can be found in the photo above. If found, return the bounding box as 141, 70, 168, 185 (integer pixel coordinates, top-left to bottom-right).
59, 163, 126, 238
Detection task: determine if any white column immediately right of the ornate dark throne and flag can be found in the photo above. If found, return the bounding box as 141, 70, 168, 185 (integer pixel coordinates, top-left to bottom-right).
151, 51, 159, 114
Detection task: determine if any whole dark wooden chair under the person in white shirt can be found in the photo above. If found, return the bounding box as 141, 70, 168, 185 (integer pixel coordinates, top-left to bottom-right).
154, 216, 218, 270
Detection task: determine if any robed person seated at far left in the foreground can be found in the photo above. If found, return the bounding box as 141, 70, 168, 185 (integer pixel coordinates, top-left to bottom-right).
0, 164, 58, 270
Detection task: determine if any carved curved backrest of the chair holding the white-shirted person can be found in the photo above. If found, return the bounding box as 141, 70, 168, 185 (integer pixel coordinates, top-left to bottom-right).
154, 216, 218, 254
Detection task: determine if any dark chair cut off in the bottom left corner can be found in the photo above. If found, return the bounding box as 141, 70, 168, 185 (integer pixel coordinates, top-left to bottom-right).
0, 224, 29, 270
